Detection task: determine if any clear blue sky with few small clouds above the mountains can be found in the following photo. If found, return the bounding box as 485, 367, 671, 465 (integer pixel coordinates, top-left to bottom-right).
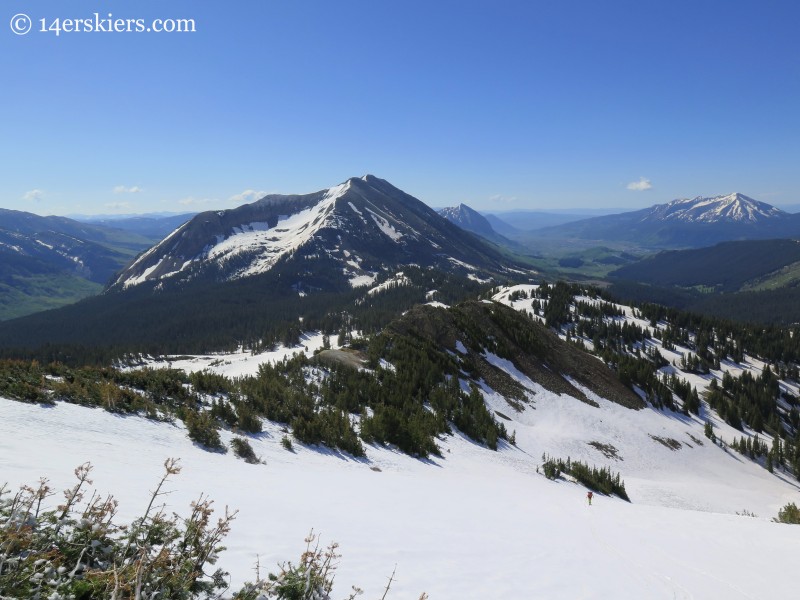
0, 0, 800, 214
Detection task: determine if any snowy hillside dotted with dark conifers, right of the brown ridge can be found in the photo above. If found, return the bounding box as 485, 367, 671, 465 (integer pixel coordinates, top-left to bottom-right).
495, 283, 800, 475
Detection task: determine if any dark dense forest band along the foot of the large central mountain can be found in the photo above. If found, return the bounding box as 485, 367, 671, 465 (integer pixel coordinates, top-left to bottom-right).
0, 266, 486, 366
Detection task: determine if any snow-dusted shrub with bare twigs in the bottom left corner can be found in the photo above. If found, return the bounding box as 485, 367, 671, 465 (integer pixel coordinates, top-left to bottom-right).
0, 459, 235, 600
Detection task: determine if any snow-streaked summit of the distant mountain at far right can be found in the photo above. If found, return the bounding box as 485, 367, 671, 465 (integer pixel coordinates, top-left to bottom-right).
643, 192, 787, 223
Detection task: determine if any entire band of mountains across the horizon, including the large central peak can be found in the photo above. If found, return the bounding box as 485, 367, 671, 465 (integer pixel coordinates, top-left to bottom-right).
0, 185, 800, 330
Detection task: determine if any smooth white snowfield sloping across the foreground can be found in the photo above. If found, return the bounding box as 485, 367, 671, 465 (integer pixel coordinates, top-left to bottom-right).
0, 394, 800, 600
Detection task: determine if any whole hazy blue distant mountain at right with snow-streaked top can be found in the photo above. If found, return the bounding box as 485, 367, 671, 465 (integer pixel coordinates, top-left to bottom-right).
537, 193, 800, 248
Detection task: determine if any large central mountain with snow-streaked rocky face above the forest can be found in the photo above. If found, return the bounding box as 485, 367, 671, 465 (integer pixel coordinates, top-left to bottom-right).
112, 175, 520, 290
